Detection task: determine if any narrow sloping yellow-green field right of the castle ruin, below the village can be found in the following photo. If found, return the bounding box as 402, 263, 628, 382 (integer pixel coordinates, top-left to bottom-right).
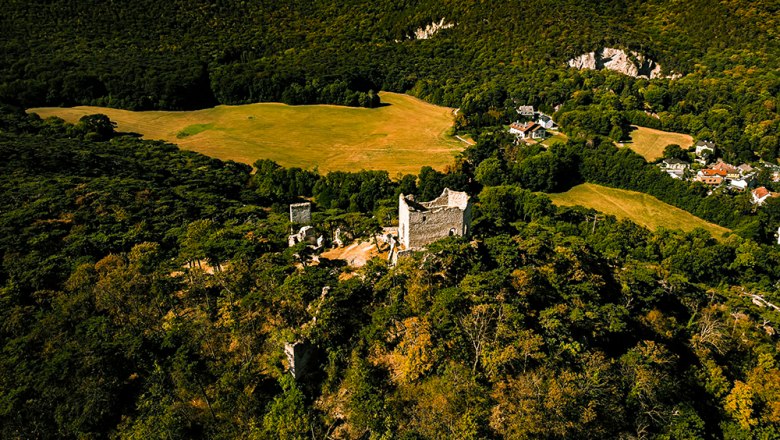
549, 183, 729, 238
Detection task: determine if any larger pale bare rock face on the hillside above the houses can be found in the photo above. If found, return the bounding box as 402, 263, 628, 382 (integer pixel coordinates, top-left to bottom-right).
569, 47, 679, 79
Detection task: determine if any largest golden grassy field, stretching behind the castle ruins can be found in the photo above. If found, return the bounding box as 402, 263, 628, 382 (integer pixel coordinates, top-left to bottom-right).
28, 92, 465, 177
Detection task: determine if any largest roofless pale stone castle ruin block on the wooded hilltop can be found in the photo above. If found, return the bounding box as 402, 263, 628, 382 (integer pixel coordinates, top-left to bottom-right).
398, 188, 471, 250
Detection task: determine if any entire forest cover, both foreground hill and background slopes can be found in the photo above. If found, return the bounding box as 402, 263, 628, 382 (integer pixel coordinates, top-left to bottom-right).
0, 0, 780, 440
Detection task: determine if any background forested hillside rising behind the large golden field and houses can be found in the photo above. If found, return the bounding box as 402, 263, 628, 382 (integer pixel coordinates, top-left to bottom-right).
0, 0, 780, 160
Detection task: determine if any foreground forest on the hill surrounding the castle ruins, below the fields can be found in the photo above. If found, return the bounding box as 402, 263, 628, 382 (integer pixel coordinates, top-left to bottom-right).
0, 107, 780, 439
